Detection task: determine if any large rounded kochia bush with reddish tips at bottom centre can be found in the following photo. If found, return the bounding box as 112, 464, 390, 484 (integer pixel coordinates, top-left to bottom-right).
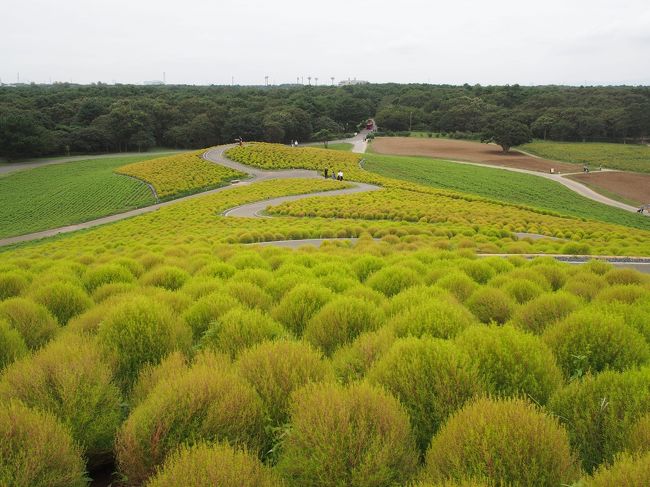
278, 383, 418, 487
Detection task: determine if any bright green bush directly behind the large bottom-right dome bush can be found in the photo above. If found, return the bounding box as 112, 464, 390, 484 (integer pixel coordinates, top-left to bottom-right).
456, 326, 562, 404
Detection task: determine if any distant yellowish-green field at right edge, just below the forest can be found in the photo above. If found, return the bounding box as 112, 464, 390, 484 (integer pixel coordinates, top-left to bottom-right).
518, 140, 650, 173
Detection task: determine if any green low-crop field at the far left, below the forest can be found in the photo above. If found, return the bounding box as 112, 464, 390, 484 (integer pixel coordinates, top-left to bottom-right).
0, 154, 170, 237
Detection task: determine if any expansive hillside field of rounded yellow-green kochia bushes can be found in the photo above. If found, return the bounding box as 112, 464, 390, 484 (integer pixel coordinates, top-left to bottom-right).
0, 144, 650, 487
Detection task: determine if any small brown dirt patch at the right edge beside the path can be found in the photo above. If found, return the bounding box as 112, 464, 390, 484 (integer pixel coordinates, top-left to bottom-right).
570, 171, 650, 205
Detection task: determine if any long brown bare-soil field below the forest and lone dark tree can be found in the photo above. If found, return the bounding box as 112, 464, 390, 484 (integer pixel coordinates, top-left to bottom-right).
371, 137, 581, 173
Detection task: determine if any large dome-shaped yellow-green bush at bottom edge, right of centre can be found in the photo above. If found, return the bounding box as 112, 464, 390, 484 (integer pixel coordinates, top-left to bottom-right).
424, 398, 580, 487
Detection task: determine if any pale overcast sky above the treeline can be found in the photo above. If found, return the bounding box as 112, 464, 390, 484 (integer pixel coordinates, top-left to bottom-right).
0, 0, 650, 85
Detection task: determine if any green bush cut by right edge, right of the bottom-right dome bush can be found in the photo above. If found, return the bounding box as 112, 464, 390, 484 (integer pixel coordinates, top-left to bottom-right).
548, 368, 650, 472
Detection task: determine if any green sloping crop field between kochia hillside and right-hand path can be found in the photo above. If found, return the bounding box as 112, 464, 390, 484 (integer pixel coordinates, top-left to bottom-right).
364, 154, 650, 230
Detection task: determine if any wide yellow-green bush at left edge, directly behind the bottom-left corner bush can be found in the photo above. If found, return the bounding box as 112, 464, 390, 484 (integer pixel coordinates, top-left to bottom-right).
0, 335, 122, 464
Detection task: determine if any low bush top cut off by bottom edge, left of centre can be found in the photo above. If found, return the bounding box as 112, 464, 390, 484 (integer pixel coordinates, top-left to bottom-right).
145, 442, 282, 487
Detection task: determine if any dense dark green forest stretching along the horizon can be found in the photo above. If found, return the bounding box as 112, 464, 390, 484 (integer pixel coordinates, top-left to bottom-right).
0, 83, 650, 158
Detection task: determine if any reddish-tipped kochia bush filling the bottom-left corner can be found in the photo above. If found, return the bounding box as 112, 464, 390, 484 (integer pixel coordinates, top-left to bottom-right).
0, 401, 87, 487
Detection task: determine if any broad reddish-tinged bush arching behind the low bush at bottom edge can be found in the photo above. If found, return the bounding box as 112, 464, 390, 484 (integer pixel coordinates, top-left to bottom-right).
115, 363, 265, 485
